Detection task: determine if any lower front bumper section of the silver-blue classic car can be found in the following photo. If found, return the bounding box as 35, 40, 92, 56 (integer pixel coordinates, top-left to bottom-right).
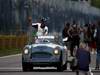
22, 56, 60, 66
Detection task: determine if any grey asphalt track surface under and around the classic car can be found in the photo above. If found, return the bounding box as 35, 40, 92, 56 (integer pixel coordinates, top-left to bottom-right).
0, 54, 100, 75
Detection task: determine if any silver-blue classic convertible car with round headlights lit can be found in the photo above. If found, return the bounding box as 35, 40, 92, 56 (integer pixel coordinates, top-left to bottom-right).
22, 36, 67, 71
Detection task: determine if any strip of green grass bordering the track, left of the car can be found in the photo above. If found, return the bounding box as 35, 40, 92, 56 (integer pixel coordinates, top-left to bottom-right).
0, 48, 22, 57
